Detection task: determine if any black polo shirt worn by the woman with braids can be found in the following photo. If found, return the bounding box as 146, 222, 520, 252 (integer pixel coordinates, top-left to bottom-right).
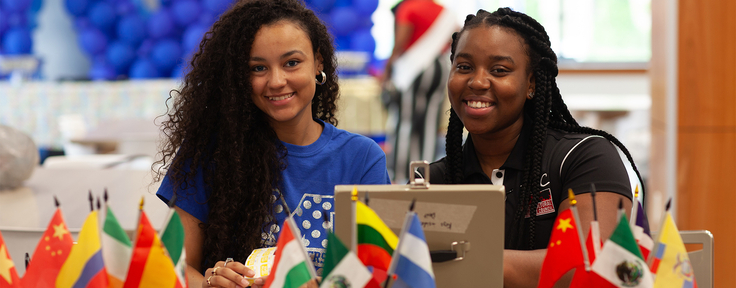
429, 122, 632, 249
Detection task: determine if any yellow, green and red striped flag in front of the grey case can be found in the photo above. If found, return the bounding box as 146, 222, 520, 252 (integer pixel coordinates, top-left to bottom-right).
356, 201, 399, 283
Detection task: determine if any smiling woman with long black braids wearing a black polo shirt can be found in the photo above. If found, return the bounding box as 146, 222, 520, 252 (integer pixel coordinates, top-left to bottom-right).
430, 8, 641, 287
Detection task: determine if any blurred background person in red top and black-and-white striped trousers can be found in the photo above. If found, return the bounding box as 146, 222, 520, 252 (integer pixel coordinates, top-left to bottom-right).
382, 0, 458, 182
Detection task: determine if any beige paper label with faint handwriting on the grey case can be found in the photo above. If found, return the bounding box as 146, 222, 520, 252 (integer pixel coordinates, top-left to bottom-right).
370, 198, 477, 233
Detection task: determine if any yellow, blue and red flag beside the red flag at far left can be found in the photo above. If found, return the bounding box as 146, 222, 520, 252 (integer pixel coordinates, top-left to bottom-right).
56, 211, 107, 288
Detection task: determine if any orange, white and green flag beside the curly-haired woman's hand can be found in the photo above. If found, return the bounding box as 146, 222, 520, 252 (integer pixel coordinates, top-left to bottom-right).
263, 216, 316, 288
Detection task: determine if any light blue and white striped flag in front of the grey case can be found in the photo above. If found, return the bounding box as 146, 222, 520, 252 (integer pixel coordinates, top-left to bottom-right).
389, 211, 436, 288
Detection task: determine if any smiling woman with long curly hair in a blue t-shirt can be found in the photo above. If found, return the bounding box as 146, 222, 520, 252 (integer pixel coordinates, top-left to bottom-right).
157, 0, 390, 287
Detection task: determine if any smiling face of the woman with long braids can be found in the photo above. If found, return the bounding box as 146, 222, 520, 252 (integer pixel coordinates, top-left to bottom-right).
447, 25, 534, 135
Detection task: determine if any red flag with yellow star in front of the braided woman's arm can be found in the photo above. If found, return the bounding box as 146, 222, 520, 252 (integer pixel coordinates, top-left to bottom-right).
537, 209, 584, 288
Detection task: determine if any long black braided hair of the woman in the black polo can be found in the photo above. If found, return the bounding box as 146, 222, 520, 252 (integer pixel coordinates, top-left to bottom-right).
445, 8, 644, 249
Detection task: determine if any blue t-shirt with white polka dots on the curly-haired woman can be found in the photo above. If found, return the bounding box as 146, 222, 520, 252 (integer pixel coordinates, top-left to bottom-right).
156, 120, 391, 274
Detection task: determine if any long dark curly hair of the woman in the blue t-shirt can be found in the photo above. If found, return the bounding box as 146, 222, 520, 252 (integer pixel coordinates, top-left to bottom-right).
154, 0, 339, 270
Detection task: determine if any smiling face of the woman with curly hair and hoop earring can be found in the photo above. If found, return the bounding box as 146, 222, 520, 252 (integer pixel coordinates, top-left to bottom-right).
248, 20, 323, 128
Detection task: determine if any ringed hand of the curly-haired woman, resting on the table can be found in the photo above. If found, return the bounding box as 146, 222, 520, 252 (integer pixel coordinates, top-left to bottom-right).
202, 261, 258, 288
